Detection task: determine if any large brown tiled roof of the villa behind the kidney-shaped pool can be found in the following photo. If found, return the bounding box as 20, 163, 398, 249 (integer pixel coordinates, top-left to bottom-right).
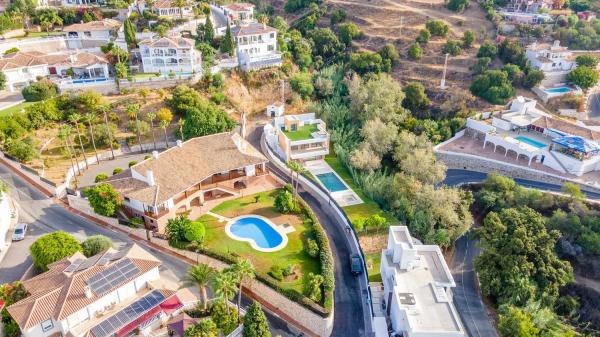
113, 133, 267, 205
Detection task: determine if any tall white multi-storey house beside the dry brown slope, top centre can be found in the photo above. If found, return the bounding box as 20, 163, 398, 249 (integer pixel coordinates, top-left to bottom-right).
231, 22, 282, 71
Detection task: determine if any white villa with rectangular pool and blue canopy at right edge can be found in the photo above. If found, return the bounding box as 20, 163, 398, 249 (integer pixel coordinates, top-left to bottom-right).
465, 96, 600, 176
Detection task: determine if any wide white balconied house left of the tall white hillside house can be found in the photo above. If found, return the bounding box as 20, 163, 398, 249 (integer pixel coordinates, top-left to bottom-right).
138, 37, 202, 75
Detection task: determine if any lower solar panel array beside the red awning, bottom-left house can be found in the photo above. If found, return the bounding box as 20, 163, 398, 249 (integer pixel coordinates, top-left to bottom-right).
91, 290, 165, 337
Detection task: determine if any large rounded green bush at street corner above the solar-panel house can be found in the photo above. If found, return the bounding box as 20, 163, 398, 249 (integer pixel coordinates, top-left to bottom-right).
29, 231, 81, 271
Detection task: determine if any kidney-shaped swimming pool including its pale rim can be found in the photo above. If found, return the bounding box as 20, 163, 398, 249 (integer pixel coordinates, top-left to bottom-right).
225, 215, 288, 252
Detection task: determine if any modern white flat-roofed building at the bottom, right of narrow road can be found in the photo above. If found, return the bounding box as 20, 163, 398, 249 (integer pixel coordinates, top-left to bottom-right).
381, 226, 466, 337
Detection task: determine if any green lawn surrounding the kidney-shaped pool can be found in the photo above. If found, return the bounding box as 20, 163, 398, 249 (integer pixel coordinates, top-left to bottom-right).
198, 190, 320, 293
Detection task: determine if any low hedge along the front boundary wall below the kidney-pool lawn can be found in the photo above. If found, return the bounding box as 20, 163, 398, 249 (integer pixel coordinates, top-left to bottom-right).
200, 242, 333, 317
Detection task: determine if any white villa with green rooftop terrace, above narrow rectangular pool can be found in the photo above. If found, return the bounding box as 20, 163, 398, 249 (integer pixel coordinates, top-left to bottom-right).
265, 113, 329, 162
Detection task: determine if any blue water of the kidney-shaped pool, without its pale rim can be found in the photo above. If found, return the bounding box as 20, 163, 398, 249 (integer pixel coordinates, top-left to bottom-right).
229, 216, 283, 249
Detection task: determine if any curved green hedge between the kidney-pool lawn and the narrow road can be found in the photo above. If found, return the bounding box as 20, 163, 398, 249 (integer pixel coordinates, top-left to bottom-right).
298, 198, 335, 314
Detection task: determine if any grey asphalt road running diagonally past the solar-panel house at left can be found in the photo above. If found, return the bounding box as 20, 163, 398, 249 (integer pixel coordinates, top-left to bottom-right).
0, 164, 301, 337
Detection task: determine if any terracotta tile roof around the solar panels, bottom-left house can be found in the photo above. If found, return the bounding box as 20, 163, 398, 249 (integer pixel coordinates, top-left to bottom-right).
7, 244, 161, 330
